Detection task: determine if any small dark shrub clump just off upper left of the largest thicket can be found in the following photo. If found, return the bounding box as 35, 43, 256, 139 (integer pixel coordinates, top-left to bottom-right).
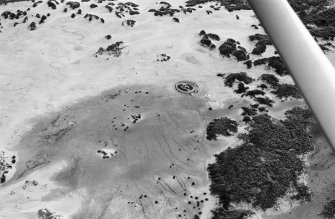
206, 117, 238, 141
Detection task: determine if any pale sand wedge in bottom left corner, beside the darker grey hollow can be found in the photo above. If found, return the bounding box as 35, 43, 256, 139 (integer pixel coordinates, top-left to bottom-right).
0, 161, 82, 218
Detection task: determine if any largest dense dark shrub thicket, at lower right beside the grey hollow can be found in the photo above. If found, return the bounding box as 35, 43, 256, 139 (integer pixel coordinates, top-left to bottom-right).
208, 108, 316, 215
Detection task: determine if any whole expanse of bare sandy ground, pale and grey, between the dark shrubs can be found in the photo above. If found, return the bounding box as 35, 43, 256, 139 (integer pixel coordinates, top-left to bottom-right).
0, 0, 335, 218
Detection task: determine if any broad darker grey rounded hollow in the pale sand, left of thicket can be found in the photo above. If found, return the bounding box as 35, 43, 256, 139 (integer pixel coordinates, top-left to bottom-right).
14, 86, 220, 218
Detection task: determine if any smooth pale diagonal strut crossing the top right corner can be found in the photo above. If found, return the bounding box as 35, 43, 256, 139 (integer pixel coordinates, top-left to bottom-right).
248, 0, 335, 151
